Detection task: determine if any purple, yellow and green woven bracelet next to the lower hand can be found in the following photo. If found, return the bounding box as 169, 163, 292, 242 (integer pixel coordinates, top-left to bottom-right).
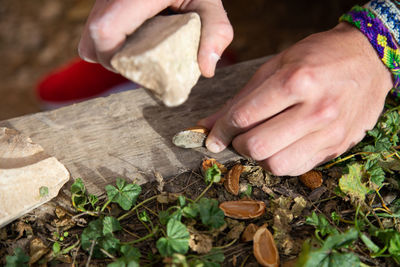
339, 6, 400, 98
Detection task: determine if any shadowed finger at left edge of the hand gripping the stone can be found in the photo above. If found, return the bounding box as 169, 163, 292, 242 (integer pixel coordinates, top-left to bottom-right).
78, 0, 107, 63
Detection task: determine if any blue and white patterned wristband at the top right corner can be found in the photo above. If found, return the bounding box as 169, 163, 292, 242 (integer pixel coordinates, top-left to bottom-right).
366, 0, 400, 44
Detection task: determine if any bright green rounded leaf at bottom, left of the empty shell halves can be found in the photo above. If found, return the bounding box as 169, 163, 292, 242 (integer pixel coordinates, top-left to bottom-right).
156, 219, 190, 257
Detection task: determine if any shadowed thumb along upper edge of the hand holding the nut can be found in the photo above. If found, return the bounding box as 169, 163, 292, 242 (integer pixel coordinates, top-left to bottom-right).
197, 56, 279, 129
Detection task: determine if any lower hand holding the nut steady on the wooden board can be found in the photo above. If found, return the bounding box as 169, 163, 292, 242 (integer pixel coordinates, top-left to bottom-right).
199, 23, 393, 176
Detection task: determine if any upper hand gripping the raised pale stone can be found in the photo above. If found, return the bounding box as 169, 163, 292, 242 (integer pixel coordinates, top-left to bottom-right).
78, 0, 233, 77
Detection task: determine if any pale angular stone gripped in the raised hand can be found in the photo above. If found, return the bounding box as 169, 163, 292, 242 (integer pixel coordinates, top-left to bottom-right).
111, 12, 201, 107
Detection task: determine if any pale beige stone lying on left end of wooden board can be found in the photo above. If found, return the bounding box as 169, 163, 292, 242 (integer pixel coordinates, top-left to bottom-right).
0, 127, 69, 228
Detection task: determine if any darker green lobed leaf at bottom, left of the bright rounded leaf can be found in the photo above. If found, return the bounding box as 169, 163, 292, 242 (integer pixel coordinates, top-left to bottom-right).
81, 216, 121, 258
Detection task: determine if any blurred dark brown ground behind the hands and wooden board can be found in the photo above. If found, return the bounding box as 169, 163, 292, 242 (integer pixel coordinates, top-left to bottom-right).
0, 0, 357, 120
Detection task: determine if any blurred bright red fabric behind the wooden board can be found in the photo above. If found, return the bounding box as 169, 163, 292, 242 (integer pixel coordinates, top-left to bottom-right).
36, 59, 127, 102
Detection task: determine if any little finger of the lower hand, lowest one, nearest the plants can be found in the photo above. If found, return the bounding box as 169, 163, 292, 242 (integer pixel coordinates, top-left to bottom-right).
259, 127, 347, 176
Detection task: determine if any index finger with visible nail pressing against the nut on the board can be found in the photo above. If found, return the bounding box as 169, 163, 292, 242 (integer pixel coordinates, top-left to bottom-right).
206, 68, 297, 153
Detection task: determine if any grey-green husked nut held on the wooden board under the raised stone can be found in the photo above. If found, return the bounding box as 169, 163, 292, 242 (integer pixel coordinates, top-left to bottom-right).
172, 126, 209, 148
